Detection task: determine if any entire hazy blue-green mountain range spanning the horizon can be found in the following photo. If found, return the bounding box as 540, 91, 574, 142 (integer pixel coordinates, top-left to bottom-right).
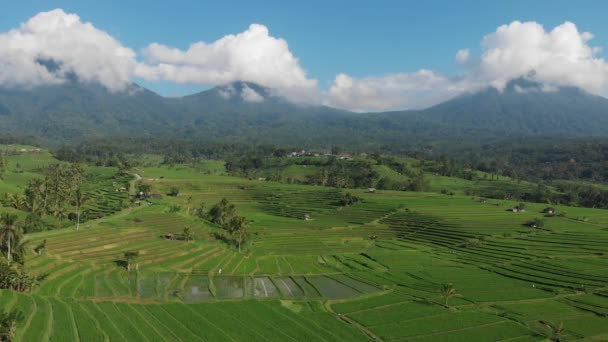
0, 79, 608, 146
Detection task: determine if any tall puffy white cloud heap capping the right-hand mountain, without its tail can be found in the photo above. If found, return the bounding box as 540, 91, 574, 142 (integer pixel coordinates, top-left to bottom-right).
472, 21, 608, 96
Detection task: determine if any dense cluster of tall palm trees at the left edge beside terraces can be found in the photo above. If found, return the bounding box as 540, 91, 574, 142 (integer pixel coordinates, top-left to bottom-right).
5, 164, 90, 233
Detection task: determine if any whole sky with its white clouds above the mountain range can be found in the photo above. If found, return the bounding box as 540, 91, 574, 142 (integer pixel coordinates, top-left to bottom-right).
0, 0, 608, 111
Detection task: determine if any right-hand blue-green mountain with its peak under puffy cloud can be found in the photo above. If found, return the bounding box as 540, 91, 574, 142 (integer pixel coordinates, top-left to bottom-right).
422, 79, 608, 136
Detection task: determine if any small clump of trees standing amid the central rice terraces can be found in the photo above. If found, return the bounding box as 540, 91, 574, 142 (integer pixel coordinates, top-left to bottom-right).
205, 198, 249, 252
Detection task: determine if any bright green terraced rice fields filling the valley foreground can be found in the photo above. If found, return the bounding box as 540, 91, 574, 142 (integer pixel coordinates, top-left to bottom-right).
0, 147, 608, 342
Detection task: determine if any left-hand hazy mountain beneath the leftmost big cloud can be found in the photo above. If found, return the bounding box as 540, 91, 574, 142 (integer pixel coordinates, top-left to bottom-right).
0, 82, 176, 141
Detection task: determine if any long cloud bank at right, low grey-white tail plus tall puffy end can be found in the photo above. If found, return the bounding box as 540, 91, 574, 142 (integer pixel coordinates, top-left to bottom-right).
327, 21, 608, 111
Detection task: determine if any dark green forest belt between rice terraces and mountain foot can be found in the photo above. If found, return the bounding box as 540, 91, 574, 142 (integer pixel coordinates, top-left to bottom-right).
48, 137, 608, 208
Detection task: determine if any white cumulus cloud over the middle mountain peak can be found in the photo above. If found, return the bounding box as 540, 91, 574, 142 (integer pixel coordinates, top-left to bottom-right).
137, 24, 318, 102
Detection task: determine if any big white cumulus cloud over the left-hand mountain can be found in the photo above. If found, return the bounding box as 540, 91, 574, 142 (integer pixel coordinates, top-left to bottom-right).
0, 9, 136, 91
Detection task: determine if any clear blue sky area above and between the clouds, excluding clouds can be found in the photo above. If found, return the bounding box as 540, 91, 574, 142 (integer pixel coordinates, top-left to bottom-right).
0, 0, 608, 109
